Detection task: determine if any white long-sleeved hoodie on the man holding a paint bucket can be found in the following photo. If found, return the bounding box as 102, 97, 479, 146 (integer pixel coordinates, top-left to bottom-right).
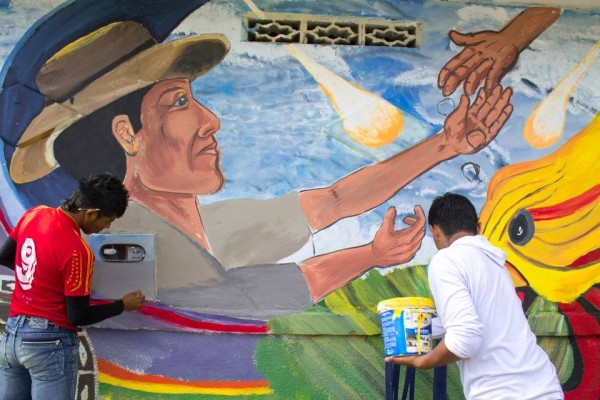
428, 236, 564, 400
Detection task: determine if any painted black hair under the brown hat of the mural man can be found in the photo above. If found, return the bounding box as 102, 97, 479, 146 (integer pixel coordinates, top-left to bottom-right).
54, 85, 153, 180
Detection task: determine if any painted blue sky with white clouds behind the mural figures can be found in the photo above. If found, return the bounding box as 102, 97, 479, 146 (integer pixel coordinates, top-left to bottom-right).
0, 0, 600, 263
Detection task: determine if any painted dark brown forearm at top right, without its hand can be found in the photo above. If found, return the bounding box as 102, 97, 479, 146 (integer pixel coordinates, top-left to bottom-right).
502, 7, 561, 51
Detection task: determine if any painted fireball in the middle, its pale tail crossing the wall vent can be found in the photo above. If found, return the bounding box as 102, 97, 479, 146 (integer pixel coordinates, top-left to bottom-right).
244, 0, 404, 147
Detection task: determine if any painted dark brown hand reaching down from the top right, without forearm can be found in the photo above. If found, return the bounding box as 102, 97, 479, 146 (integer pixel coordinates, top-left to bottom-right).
438, 30, 519, 96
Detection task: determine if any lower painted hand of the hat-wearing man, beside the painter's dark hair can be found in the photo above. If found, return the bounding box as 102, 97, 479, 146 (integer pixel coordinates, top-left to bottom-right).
371, 206, 425, 267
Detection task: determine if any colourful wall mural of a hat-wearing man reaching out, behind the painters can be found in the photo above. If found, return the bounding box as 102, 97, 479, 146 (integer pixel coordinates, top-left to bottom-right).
0, 0, 600, 399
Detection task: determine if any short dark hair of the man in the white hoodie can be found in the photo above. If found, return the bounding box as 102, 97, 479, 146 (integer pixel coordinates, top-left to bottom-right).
428, 193, 478, 237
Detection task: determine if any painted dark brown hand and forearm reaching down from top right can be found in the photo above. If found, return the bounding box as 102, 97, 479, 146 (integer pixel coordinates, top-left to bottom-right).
438, 7, 561, 96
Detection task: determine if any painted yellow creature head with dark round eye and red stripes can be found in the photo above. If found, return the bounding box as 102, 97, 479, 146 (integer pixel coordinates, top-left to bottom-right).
480, 114, 600, 303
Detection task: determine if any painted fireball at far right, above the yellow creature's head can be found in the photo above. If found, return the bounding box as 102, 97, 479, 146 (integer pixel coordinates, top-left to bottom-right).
523, 41, 600, 149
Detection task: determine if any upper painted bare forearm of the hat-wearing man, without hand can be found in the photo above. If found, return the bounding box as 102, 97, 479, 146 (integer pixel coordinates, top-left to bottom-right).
300, 134, 456, 231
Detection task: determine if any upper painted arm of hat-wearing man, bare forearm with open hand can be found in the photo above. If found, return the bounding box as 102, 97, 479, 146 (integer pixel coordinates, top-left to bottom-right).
300, 86, 512, 231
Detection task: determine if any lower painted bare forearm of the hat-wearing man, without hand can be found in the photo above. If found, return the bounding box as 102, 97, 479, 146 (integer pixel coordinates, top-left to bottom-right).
300, 244, 376, 302
